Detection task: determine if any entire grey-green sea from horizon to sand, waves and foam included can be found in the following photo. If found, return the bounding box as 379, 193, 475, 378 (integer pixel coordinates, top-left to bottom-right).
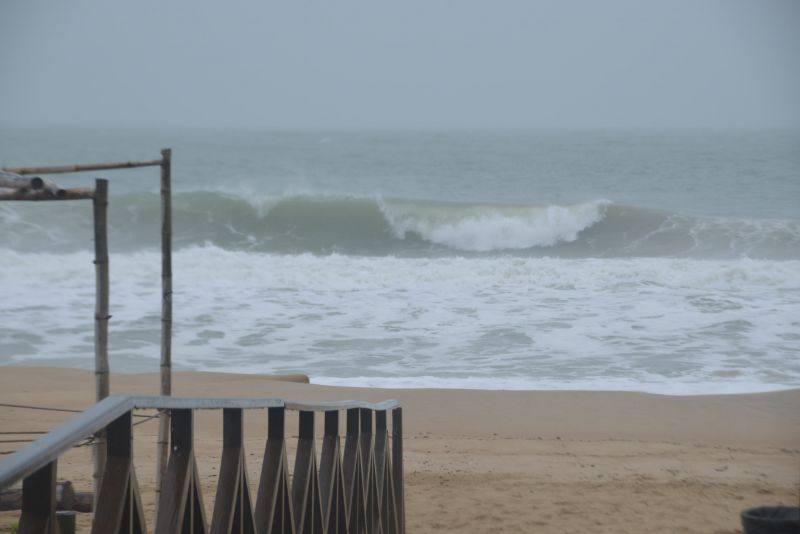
0, 128, 800, 394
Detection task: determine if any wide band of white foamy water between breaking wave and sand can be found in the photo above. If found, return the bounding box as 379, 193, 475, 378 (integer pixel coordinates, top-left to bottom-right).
0, 246, 800, 394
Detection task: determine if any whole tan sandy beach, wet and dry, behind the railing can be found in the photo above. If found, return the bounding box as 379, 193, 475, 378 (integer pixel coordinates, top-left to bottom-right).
0, 367, 800, 533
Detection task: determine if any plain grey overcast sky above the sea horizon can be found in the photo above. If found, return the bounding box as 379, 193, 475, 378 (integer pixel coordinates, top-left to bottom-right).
0, 0, 800, 128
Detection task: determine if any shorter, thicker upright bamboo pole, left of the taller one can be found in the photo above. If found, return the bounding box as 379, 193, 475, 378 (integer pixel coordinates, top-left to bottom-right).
92, 179, 111, 506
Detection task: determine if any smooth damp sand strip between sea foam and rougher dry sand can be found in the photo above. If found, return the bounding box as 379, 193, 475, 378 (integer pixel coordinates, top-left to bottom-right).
0, 366, 800, 447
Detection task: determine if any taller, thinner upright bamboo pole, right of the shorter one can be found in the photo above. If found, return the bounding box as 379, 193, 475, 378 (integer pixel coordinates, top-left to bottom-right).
156, 148, 172, 516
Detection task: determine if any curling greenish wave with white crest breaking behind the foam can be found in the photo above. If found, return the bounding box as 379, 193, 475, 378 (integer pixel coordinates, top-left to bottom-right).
0, 192, 800, 260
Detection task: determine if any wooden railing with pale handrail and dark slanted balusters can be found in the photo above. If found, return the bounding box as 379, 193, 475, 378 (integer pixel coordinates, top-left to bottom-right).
0, 396, 405, 534
